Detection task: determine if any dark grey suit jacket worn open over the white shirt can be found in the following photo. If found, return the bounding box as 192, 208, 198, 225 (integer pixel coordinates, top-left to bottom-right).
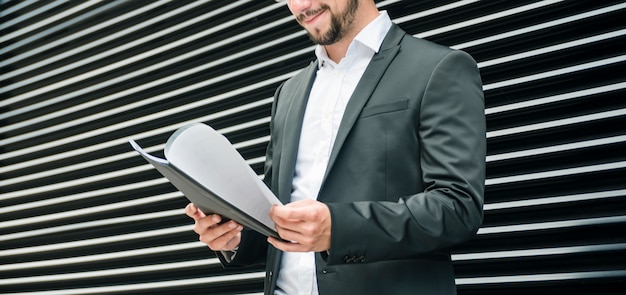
222, 25, 486, 295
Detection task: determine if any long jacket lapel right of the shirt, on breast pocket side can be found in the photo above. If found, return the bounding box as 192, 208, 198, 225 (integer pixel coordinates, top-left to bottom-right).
320, 24, 405, 188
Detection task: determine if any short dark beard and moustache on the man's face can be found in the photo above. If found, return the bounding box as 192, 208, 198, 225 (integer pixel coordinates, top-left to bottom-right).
296, 0, 359, 45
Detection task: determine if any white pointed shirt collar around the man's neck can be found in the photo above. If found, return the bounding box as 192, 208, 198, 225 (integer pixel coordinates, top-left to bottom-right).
315, 10, 392, 68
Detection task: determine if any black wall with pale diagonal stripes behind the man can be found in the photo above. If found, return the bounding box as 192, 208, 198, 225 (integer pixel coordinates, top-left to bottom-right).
0, 0, 626, 295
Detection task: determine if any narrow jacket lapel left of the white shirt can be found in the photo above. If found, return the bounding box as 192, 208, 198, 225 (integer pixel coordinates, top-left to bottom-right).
278, 62, 317, 203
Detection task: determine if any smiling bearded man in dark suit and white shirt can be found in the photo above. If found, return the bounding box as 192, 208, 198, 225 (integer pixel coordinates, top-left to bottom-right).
186, 0, 486, 295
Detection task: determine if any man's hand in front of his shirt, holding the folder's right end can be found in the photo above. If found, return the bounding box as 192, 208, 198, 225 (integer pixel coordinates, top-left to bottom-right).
267, 200, 331, 252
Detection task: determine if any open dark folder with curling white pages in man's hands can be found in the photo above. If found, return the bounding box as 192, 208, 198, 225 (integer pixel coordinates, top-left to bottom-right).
129, 123, 282, 238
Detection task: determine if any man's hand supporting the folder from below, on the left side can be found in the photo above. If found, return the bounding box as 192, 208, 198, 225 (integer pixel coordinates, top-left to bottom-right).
185, 203, 243, 251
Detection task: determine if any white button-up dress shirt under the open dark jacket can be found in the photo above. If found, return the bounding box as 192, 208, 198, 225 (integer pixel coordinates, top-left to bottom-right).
276, 11, 392, 295
